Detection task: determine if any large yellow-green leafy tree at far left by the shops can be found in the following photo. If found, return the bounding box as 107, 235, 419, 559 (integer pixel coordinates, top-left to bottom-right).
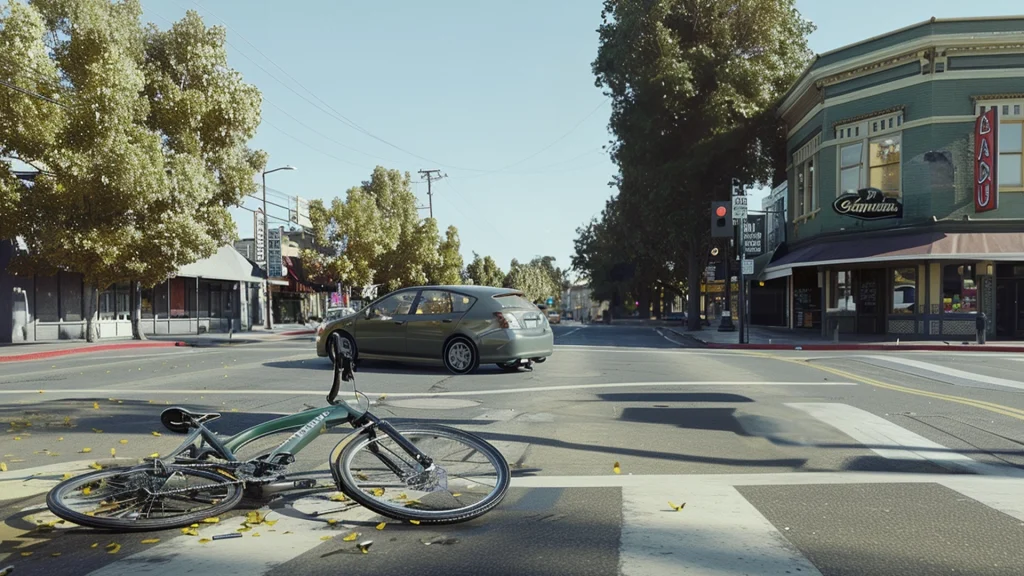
0, 0, 265, 341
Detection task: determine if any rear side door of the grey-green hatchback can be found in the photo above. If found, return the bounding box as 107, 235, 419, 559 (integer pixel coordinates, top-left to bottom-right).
406, 290, 472, 359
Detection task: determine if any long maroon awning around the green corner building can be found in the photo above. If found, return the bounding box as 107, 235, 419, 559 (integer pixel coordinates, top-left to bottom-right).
765, 232, 1024, 280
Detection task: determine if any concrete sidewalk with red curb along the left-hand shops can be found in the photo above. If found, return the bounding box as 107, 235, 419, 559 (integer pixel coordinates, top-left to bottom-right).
0, 324, 316, 363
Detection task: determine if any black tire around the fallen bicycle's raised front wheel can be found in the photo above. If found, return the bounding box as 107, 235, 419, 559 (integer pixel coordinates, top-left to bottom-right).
335, 423, 511, 524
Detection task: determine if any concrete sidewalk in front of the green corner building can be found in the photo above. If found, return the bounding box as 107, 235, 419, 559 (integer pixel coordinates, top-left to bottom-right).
669, 322, 1024, 353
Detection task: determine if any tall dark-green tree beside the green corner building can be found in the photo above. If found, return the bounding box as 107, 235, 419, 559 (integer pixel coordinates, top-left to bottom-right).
573, 0, 813, 328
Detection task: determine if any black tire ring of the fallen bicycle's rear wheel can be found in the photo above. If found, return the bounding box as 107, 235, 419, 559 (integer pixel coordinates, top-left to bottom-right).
46, 464, 243, 532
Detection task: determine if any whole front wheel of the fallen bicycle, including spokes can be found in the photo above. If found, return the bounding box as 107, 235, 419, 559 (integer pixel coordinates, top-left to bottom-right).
337, 424, 510, 524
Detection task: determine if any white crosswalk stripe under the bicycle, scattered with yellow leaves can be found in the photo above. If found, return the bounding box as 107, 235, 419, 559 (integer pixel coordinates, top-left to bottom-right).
89, 496, 380, 576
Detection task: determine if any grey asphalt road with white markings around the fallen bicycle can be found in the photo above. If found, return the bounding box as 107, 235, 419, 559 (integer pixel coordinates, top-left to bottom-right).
0, 324, 1024, 576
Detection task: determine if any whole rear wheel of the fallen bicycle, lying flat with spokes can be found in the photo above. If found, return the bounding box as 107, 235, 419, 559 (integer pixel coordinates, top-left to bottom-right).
46, 465, 242, 532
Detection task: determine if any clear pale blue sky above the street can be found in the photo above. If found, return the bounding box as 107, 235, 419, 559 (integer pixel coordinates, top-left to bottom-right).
143, 0, 1024, 276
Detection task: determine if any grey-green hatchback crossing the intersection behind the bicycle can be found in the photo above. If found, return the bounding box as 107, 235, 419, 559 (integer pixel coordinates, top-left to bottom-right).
316, 286, 554, 374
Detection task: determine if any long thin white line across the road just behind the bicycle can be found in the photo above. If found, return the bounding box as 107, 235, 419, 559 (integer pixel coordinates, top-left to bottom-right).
0, 380, 857, 399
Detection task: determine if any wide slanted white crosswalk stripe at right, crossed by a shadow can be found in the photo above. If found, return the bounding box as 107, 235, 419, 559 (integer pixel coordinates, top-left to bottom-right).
786, 403, 1024, 478
